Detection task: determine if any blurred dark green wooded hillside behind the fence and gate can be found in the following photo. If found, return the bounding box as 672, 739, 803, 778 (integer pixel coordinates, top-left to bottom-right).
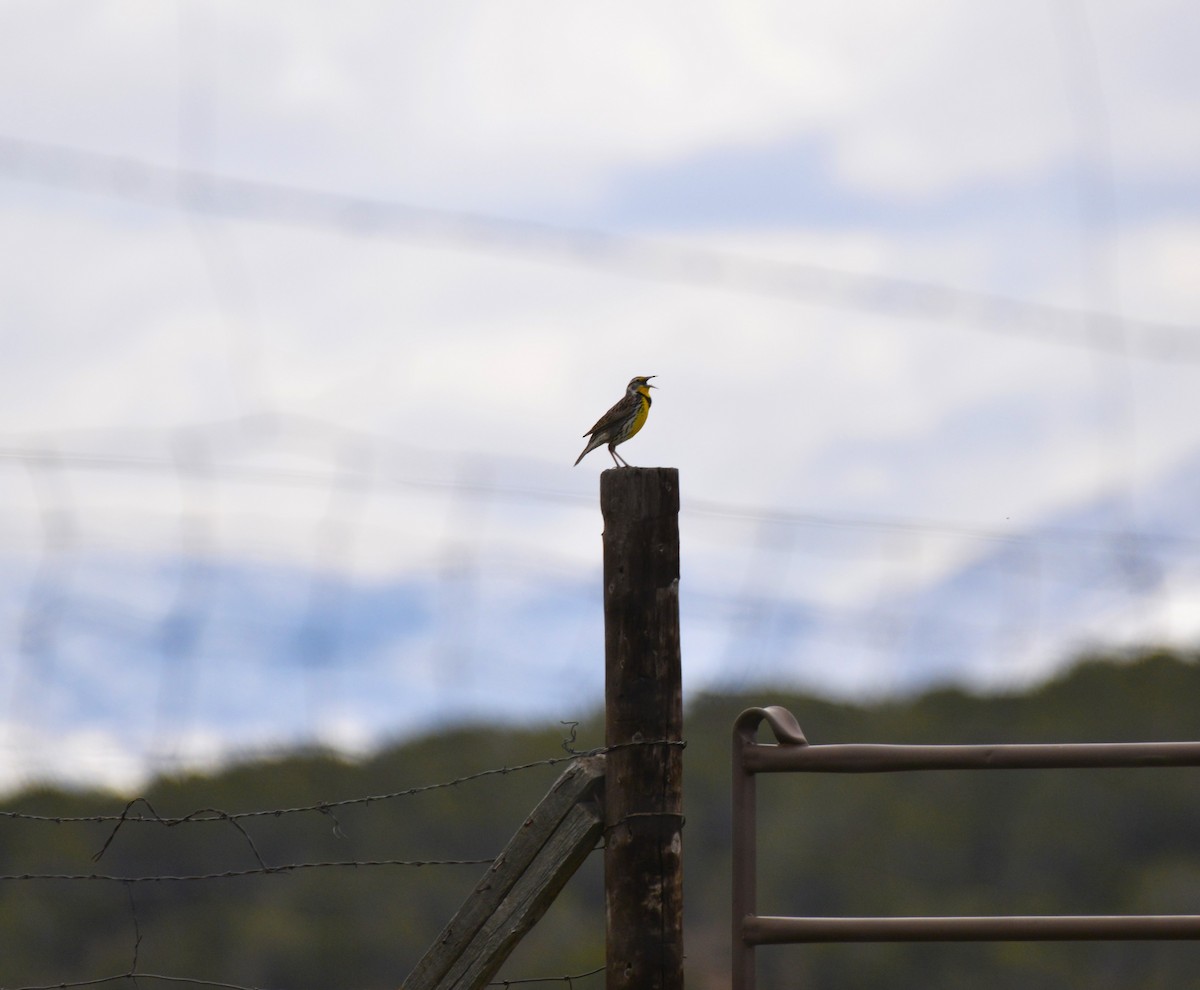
0, 653, 1200, 990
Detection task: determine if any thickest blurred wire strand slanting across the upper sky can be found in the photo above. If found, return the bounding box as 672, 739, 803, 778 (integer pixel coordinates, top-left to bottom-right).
0, 136, 1200, 364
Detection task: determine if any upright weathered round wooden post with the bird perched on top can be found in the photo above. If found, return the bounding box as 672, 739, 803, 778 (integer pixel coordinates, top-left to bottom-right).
600, 468, 683, 990
